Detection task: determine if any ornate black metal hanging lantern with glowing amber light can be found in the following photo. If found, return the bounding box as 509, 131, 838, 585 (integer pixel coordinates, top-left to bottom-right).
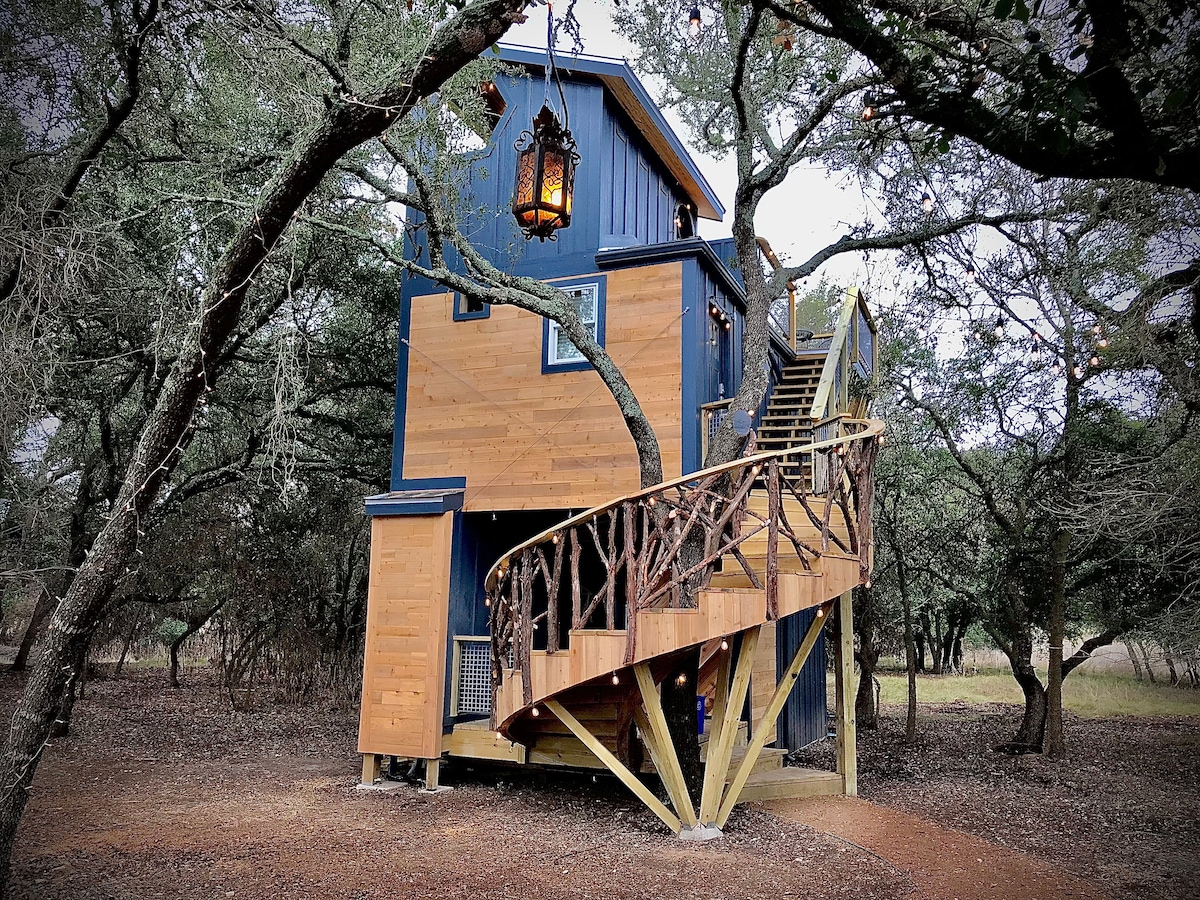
512, 106, 580, 241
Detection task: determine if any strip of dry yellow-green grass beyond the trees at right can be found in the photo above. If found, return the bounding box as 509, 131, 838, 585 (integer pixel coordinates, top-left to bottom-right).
880, 671, 1200, 718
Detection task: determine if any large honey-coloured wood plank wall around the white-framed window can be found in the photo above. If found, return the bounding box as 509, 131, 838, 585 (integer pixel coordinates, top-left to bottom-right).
403, 263, 683, 511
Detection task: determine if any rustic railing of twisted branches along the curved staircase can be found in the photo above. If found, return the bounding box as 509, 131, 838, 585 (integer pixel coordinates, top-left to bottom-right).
485, 416, 883, 725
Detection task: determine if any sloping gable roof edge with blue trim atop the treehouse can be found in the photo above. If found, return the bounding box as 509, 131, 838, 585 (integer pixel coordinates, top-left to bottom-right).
496, 44, 725, 222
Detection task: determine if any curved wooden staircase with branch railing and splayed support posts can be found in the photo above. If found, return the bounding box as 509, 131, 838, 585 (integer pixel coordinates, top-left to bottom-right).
486, 292, 883, 833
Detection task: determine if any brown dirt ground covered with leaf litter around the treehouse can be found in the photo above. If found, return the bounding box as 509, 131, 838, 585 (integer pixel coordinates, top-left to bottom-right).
0, 672, 1200, 900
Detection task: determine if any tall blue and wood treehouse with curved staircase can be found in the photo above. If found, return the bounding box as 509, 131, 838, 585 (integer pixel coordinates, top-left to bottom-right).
359, 48, 882, 832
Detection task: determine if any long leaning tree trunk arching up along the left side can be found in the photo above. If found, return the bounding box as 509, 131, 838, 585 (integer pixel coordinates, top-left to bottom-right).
0, 0, 526, 884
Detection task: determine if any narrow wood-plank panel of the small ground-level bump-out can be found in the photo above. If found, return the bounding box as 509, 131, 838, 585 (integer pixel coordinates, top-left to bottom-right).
359, 512, 454, 758
